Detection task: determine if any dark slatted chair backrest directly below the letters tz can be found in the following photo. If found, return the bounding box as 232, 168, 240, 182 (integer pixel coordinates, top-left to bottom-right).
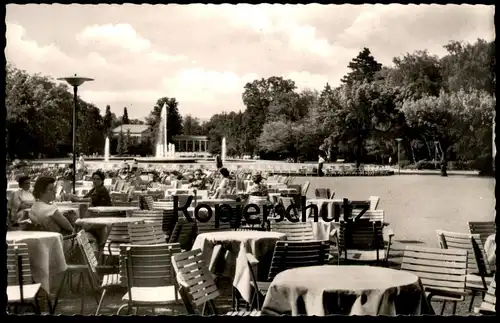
339, 219, 384, 250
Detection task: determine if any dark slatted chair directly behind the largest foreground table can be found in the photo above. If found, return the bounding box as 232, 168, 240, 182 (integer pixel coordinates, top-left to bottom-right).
247, 240, 330, 309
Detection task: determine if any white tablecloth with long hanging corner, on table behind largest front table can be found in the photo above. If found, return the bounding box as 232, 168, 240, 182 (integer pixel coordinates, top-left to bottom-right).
192, 231, 286, 302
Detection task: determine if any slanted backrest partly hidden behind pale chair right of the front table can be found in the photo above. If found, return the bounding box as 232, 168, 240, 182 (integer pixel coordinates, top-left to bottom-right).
436, 230, 491, 276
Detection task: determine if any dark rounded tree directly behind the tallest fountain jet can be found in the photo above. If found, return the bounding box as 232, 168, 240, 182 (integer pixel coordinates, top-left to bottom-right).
146, 97, 182, 149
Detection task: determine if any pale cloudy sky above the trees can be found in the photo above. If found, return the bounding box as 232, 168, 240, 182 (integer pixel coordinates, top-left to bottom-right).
5, 4, 495, 120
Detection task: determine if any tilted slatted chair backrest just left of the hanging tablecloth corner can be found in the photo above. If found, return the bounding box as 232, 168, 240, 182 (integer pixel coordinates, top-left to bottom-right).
172, 249, 219, 306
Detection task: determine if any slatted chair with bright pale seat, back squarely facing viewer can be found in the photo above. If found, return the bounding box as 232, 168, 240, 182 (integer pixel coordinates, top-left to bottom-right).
116, 243, 181, 315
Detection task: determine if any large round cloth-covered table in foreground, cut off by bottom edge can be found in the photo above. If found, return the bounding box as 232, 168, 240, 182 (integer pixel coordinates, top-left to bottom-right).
262, 266, 433, 316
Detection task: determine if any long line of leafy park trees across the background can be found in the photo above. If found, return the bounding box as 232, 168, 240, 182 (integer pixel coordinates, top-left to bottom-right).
6, 39, 496, 172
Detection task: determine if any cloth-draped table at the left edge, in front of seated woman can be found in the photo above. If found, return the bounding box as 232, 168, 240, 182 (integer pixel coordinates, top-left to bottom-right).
6, 231, 66, 293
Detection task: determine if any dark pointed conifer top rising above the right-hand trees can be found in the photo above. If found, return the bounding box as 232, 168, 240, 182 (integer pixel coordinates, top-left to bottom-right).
341, 47, 382, 85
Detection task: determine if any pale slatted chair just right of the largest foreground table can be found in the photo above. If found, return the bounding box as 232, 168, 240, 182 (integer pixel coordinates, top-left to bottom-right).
401, 246, 469, 315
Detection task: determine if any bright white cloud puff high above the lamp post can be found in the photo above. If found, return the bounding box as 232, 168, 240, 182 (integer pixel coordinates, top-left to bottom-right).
76, 24, 151, 52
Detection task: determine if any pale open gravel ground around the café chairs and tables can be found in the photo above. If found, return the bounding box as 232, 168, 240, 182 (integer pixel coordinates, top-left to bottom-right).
13, 175, 495, 315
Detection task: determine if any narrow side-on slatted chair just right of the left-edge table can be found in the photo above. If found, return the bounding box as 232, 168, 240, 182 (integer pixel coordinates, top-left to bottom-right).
76, 230, 126, 315
